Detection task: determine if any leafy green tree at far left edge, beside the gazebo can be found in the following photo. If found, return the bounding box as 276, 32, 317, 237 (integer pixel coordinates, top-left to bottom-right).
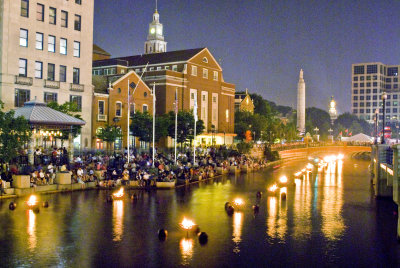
0, 102, 32, 163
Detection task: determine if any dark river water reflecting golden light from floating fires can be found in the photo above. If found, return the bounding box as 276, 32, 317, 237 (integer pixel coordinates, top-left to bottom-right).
0, 159, 400, 267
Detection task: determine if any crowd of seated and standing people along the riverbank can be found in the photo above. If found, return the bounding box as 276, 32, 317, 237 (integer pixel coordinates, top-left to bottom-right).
0, 148, 263, 191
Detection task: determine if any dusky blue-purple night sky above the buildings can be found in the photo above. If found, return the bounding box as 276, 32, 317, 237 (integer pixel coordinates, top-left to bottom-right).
94, 0, 400, 113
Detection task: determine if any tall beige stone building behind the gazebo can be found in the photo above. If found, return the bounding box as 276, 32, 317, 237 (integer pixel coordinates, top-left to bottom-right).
0, 0, 94, 151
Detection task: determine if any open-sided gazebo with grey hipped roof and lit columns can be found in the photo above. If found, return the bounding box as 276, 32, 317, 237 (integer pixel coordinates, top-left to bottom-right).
14, 99, 86, 164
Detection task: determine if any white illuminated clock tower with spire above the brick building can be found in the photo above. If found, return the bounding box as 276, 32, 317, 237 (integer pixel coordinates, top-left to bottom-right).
144, 2, 167, 54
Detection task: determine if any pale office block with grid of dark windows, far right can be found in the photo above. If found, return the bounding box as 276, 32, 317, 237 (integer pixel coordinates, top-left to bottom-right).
351, 62, 400, 124
